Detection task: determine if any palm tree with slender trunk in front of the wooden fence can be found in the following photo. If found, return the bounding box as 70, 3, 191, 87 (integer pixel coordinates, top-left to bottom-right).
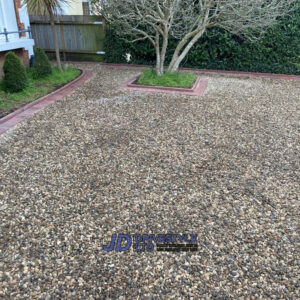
23, 0, 69, 72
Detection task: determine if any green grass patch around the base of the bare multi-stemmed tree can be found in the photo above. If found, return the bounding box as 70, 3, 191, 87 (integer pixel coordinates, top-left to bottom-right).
137, 70, 197, 88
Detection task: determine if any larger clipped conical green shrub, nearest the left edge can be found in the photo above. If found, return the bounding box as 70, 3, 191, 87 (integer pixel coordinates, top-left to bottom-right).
3, 51, 28, 93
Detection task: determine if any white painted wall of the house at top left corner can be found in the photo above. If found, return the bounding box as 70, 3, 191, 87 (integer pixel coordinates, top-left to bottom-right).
0, 0, 34, 56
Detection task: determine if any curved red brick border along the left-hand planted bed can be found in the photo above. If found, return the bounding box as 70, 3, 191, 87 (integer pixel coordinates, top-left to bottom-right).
0, 70, 93, 135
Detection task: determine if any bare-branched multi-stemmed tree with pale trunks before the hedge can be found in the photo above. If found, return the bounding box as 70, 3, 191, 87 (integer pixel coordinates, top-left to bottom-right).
93, 0, 299, 75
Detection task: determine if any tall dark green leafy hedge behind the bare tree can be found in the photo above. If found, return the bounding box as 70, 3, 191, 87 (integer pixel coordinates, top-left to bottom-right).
105, 4, 300, 74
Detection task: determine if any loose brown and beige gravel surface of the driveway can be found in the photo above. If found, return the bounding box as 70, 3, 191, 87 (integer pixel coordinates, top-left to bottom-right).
0, 64, 300, 299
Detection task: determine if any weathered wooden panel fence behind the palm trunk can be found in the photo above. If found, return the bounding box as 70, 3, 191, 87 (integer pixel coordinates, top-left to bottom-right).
30, 15, 105, 60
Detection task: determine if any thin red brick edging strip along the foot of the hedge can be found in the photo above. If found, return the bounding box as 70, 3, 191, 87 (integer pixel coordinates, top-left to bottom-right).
99, 62, 300, 81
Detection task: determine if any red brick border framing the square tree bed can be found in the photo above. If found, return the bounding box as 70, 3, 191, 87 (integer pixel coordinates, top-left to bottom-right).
119, 74, 208, 96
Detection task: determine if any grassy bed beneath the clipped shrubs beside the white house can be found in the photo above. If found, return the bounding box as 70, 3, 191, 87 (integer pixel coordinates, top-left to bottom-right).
0, 67, 80, 118
